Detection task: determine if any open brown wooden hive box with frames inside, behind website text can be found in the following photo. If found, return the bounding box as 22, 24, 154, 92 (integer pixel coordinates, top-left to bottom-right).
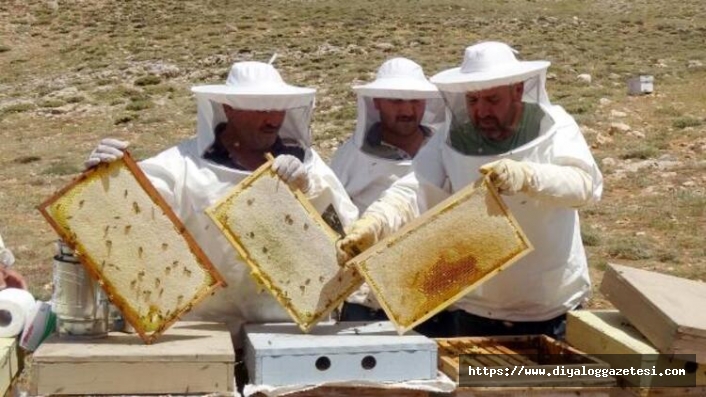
436, 335, 615, 388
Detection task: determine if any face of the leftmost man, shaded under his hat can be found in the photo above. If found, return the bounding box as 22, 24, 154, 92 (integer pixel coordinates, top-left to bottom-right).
224, 105, 286, 150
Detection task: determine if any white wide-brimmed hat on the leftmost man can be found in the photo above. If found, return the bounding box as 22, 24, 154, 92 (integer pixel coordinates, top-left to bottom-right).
191, 62, 316, 110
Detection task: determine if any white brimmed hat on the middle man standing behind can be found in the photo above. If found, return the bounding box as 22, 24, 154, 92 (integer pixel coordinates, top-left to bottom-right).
353, 58, 441, 99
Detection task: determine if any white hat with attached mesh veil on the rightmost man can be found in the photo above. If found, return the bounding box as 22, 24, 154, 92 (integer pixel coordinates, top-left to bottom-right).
431, 41, 551, 148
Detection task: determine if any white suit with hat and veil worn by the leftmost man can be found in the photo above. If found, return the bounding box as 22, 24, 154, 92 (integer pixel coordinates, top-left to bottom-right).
135, 62, 358, 342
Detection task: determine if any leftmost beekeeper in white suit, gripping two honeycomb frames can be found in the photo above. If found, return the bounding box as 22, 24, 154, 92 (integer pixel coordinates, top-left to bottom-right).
86, 62, 358, 344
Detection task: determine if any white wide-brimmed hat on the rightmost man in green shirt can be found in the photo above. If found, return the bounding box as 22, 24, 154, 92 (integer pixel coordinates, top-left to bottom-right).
431, 42, 551, 92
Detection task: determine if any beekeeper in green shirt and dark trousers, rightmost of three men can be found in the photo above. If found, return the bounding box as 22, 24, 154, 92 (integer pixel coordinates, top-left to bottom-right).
338, 42, 603, 337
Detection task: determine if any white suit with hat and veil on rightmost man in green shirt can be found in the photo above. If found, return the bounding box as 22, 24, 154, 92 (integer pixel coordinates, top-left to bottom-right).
341, 42, 603, 322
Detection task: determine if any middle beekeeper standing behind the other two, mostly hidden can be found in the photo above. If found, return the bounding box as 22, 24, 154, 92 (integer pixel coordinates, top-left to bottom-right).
331, 58, 448, 321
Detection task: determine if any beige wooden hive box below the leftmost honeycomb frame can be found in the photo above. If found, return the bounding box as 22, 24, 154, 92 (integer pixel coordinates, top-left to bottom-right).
30, 322, 235, 395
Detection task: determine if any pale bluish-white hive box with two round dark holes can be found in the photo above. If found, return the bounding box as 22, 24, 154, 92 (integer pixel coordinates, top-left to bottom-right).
245, 321, 437, 386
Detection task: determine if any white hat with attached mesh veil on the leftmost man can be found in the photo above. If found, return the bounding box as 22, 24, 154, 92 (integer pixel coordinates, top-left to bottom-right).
191, 62, 316, 155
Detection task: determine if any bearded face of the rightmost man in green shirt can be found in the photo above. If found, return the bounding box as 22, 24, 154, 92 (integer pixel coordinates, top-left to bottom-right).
466, 83, 523, 140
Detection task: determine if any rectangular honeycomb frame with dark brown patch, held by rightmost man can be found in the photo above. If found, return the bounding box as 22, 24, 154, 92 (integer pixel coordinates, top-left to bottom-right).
349, 180, 533, 334
